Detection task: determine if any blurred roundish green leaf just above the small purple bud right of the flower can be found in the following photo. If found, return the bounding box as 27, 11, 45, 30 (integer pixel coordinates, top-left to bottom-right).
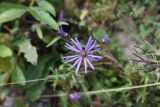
93, 27, 106, 41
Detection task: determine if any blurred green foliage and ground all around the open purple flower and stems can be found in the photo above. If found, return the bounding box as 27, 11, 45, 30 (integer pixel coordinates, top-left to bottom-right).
0, 0, 160, 107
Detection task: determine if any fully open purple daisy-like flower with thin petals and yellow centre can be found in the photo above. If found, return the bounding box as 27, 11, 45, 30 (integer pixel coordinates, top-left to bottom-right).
63, 37, 102, 74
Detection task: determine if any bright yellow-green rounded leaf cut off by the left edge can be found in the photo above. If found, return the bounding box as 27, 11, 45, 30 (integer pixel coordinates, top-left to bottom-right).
0, 45, 12, 57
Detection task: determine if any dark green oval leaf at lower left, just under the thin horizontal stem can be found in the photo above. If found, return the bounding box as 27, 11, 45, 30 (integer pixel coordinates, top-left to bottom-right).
26, 81, 45, 102
